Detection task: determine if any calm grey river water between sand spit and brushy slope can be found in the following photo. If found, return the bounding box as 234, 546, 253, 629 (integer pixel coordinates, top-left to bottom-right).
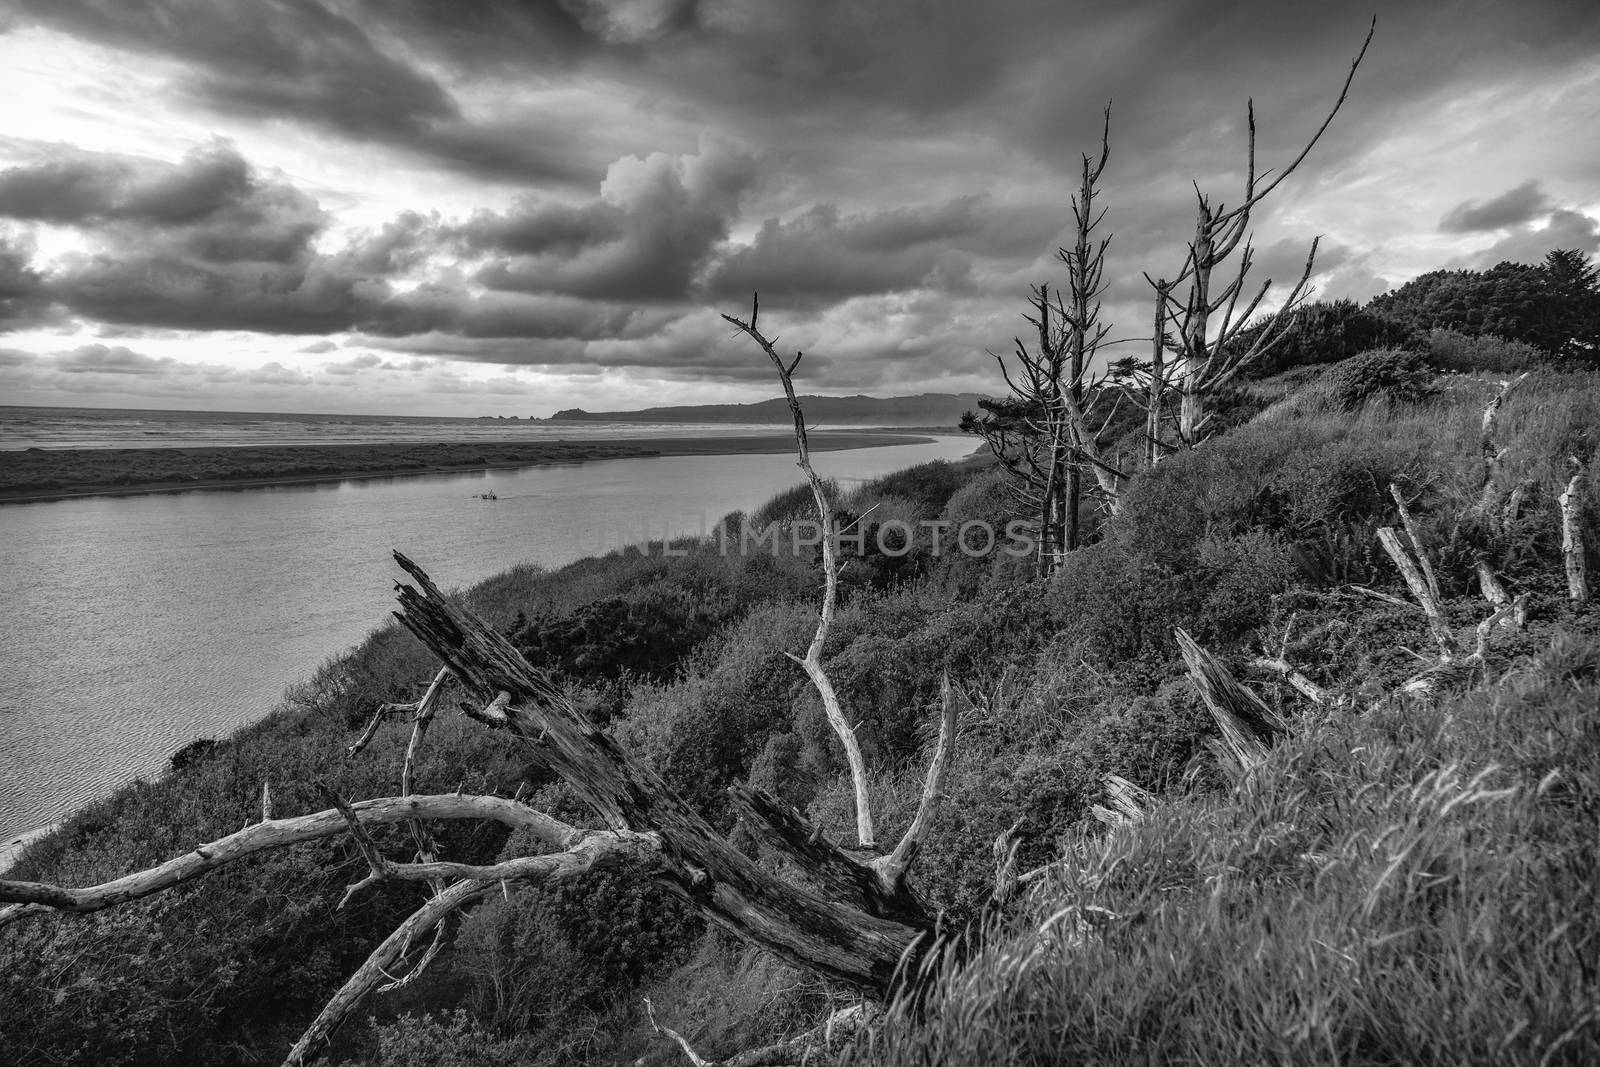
0, 437, 973, 845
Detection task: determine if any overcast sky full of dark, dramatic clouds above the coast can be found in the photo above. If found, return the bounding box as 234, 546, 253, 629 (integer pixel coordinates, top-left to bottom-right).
0, 0, 1600, 418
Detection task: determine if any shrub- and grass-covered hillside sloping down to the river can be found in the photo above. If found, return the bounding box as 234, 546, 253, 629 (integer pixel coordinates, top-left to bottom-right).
0, 342, 1600, 1067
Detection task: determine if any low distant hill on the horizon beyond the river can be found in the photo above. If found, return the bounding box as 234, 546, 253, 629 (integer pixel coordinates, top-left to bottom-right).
550, 394, 978, 427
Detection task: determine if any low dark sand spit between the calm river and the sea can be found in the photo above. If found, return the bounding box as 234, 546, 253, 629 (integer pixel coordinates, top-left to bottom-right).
0, 427, 934, 504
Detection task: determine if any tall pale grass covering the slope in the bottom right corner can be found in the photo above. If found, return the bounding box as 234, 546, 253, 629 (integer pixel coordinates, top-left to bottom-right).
851, 633, 1600, 1067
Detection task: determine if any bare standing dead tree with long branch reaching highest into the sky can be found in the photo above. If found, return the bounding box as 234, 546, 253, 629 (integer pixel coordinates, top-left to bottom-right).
1146, 16, 1378, 448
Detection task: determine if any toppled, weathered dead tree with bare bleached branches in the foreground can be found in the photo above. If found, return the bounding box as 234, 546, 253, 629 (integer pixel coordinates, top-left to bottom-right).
0, 329, 955, 1065
